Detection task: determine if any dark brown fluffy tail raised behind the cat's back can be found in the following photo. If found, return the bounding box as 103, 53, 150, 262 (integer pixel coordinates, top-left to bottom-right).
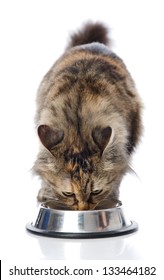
67, 22, 110, 49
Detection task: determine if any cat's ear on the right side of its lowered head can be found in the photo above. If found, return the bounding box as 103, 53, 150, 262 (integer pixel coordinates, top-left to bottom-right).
92, 126, 112, 152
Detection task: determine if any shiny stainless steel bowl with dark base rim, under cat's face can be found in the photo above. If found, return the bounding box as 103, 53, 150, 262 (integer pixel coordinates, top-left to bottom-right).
26, 204, 138, 238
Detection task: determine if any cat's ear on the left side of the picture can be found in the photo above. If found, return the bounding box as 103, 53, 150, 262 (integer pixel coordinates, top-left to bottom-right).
38, 125, 64, 150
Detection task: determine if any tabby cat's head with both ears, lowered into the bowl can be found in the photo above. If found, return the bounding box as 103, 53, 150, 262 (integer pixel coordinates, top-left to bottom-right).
35, 122, 127, 210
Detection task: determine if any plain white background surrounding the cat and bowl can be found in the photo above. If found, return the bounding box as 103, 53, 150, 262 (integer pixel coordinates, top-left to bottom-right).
0, 0, 164, 262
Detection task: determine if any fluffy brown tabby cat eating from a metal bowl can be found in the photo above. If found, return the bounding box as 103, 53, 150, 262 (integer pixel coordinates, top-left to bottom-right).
34, 22, 142, 210
